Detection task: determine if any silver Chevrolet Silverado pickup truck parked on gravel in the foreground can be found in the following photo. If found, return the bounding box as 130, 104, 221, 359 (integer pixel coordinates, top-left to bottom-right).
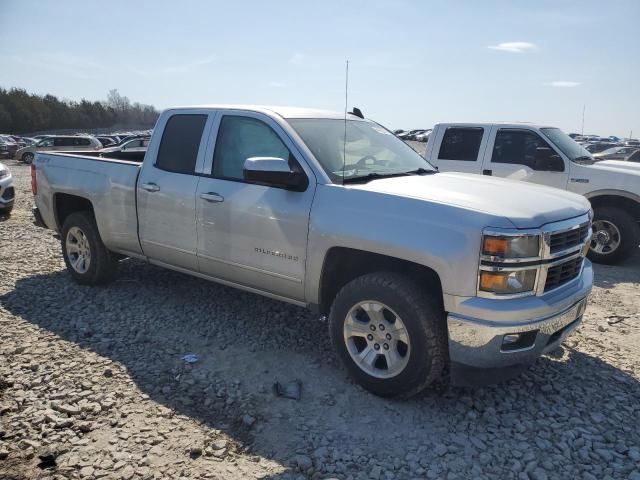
32, 106, 593, 397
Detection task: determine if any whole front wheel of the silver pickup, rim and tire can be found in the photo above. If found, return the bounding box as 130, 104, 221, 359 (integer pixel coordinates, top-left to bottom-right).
329, 273, 447, 397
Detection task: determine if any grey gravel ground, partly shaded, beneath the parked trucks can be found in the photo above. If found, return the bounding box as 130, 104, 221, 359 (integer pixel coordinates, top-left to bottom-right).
0, 161, 640, 480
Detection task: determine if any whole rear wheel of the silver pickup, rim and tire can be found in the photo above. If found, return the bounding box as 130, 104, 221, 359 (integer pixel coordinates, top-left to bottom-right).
62, 212, 118, 285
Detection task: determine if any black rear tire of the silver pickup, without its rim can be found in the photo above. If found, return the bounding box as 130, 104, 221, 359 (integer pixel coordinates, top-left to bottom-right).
61, 212, 118, 285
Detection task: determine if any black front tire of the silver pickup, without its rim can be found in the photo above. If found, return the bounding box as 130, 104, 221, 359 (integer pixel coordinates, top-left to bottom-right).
329, 272, 448, 398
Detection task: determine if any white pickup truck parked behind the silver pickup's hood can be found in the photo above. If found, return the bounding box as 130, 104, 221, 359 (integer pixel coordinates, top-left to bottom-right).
425, 123, 640, 264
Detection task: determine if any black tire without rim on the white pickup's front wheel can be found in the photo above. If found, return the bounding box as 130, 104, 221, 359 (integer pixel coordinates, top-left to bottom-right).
587, 207, 640, 265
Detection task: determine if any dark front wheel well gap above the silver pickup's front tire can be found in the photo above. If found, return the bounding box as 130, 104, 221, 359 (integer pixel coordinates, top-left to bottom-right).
319, 247, 442, 315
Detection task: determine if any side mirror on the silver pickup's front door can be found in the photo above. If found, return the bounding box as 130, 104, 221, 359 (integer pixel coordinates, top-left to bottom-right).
243, 157, 309, 192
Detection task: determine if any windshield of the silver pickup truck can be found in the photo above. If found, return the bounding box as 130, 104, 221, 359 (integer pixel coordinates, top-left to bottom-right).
288, 118, 436, 183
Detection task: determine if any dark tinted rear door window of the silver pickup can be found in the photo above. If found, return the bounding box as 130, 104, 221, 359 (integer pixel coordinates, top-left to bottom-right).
155, 114, 207, 174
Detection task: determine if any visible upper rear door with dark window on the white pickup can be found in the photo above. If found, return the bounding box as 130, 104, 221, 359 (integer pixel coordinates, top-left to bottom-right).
428, 125, 488, 173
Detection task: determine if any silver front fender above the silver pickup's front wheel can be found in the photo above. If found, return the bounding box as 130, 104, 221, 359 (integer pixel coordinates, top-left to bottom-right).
305, 185, 512, 303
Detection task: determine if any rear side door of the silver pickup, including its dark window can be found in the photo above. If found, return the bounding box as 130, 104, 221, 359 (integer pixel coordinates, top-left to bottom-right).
137, 112, 209, 271
